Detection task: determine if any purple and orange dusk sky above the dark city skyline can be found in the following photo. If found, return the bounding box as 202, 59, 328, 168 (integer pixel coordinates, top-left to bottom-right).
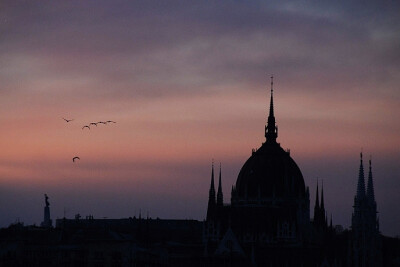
0, 0, 400, 236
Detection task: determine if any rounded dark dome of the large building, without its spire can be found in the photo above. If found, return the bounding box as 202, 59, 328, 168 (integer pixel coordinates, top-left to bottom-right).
235, 142, 305, 200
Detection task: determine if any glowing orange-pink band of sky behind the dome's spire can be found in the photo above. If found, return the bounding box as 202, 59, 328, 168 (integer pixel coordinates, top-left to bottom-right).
0, 87, 400, 186
